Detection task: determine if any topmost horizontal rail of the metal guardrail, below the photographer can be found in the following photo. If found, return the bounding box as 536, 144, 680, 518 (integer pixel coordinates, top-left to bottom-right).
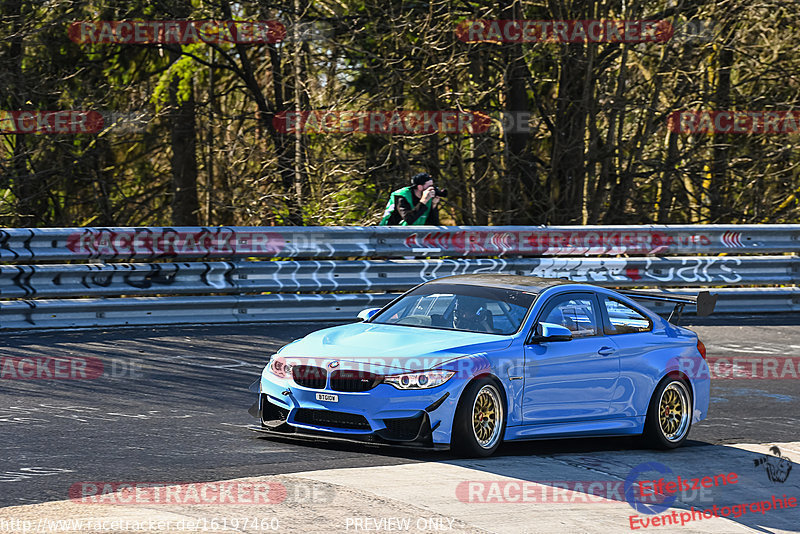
0, 225, 800, 262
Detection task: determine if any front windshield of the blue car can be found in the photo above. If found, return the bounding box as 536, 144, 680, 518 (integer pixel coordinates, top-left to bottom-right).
371, 283, 536, 335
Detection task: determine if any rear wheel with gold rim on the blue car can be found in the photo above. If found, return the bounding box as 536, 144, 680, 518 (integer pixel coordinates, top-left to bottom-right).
642, 376, 693, 450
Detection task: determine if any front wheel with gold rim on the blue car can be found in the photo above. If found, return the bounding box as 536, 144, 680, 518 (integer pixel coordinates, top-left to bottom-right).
450, 377, 506, 458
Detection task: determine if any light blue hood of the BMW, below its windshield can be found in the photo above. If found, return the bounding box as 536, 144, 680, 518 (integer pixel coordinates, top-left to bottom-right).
279, 323, 512, 372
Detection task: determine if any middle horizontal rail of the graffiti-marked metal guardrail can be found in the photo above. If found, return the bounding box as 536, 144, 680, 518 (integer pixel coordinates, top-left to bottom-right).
0, 256, 800, 298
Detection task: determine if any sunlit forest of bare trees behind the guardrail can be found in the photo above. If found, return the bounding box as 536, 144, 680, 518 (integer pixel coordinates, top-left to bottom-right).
0, 0, 800, 227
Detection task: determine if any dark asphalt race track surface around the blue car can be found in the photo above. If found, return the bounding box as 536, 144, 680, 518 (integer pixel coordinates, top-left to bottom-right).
0, 316, 800, 506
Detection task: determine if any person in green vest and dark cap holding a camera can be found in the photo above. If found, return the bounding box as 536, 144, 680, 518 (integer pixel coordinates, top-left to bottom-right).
379, 172, 447, 226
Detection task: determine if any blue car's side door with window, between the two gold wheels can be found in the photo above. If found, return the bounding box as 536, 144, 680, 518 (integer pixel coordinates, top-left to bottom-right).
522, 292, 619, 424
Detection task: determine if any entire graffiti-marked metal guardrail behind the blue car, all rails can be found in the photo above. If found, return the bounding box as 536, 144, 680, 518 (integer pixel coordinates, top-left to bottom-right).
0, 225, 800, 330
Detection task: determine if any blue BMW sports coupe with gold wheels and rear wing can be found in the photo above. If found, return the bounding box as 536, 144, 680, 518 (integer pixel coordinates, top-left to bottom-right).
252, 274, 714, 456
